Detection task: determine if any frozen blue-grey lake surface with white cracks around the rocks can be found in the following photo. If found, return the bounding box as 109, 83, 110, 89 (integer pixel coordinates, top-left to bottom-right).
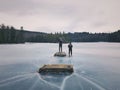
0, 42, 120, 90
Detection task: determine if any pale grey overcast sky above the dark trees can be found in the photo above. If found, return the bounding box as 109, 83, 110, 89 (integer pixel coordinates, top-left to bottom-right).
0, 0, 120, 32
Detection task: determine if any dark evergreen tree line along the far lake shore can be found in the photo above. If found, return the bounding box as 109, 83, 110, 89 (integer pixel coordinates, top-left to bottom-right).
0, 24, 120, 44
